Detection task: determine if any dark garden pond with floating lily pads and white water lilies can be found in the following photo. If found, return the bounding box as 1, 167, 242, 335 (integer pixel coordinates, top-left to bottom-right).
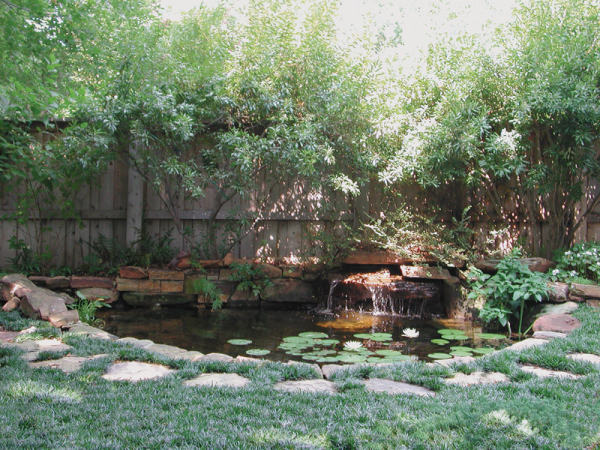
98, 307, 510, 363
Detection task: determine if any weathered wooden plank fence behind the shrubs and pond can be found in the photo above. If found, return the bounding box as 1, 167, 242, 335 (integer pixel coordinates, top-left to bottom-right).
0, 126, 600, 268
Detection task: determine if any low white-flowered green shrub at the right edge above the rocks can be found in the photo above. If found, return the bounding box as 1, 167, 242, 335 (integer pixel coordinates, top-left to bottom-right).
551, 242, 600, 283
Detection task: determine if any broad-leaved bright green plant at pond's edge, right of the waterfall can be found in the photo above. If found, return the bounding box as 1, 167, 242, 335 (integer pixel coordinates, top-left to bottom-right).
468, 252, 549, 334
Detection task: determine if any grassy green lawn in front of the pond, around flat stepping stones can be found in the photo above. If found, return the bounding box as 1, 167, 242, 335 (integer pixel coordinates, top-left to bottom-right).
0, 307, 600, 450
